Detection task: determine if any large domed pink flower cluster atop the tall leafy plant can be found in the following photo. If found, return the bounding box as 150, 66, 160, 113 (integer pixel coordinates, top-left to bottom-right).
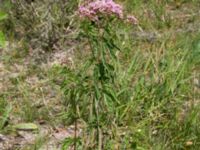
79, 0, 123, 21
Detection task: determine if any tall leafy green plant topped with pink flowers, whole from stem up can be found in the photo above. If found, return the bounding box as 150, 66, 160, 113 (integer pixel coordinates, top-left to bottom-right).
62, 0, 137, 150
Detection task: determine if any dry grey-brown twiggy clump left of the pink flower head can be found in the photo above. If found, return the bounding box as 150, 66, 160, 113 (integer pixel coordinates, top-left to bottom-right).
3, 0, 79, 54
